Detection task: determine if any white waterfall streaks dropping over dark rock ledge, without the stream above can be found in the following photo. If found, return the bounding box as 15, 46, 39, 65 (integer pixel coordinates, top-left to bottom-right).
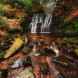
30, 14, 52, 33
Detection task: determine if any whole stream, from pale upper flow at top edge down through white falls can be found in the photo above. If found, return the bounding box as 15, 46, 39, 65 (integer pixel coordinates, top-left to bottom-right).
30, 0, 58, 33
